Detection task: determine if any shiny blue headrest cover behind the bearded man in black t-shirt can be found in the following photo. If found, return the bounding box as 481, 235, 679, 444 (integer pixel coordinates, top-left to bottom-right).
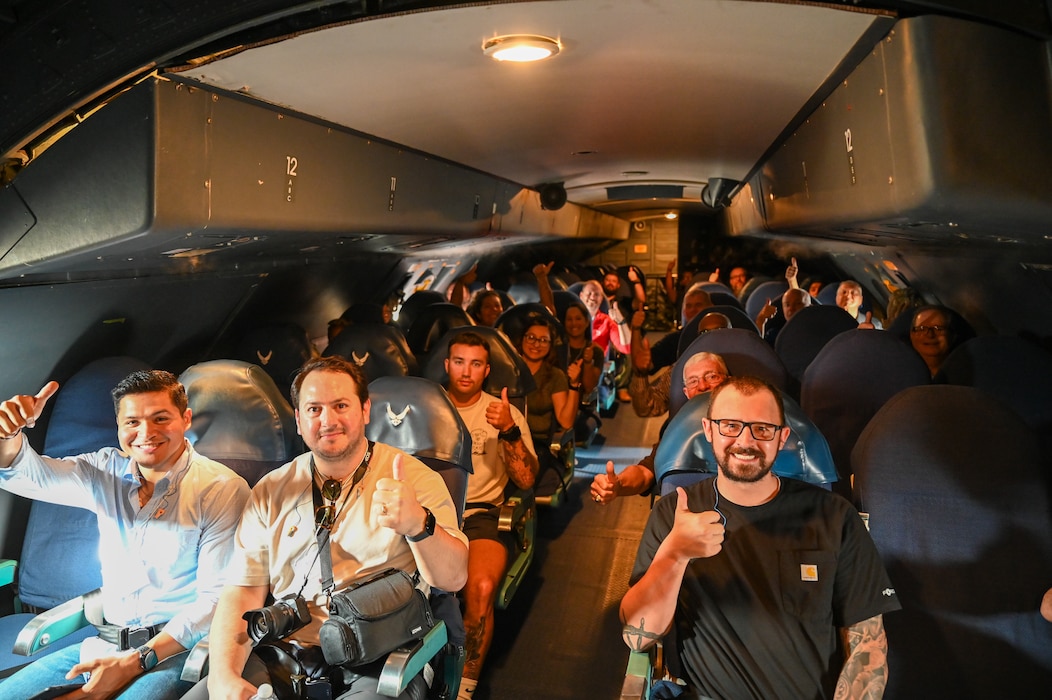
654, 393, 837, 496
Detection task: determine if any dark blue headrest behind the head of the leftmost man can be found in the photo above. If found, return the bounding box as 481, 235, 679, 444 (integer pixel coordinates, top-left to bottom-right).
44, 357, 150, 457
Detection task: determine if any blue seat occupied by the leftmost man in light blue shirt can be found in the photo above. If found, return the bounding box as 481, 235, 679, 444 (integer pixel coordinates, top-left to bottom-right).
0, 357, 149, 675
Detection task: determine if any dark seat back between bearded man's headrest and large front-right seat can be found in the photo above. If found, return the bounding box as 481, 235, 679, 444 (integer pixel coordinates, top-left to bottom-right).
800, 328, 934, 488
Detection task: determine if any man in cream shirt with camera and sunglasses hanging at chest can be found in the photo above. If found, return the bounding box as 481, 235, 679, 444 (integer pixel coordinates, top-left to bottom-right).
196, 356, 467, 700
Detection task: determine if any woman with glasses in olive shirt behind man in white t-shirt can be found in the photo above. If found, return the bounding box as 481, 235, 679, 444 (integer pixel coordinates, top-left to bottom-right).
519, 314, 583, 496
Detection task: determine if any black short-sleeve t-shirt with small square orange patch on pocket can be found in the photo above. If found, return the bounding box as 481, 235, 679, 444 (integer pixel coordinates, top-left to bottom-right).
632, 479, 901, 700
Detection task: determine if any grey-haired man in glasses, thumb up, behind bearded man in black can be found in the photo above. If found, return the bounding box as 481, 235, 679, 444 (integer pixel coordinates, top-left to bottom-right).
591, 353, 728, 505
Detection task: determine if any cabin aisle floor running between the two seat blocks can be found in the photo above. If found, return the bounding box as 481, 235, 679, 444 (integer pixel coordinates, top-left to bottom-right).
474, 404, 664, 700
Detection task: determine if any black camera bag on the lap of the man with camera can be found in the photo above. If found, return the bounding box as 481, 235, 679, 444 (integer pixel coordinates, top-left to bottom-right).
318, 568, 434, 666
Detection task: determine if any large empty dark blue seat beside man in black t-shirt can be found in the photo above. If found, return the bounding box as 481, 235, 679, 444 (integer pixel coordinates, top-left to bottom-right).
851, 385, 1052, 700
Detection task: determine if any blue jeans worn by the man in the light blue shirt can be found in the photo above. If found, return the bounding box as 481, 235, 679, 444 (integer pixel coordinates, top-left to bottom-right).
0, 644, 194, 700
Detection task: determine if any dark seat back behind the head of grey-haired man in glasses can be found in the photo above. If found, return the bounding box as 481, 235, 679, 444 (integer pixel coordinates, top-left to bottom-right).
668, 328, 792, 417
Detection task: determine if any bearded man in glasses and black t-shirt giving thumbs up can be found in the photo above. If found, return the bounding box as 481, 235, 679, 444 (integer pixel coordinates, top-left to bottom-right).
621, 377, 901, 698
